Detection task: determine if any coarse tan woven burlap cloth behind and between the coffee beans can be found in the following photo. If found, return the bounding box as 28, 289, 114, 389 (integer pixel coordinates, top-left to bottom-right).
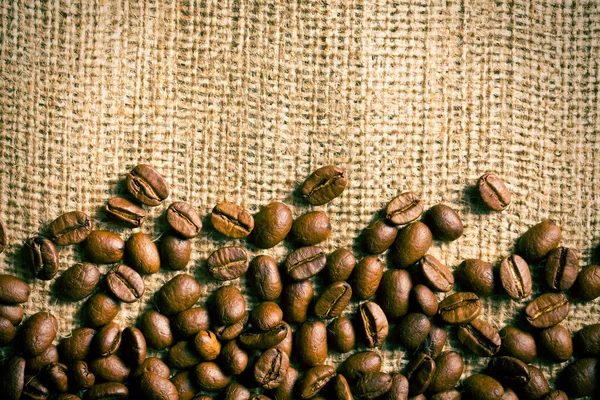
0, 0, 600, 396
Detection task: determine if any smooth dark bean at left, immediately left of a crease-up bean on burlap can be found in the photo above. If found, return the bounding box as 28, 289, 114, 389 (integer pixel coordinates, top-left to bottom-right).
56, 262, 100, 301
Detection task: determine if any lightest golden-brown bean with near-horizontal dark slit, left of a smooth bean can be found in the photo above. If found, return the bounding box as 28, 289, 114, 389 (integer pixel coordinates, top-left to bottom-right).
210, 202, 254, 239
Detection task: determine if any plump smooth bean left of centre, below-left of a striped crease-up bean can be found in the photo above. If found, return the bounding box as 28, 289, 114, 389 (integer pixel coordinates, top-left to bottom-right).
155, 274, 200, 315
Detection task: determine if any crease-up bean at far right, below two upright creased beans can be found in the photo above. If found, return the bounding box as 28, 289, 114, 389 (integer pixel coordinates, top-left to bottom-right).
525, 293, 569, 328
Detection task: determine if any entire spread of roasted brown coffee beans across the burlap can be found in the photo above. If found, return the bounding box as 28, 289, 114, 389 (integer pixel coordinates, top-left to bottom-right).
0, 165, 600, 400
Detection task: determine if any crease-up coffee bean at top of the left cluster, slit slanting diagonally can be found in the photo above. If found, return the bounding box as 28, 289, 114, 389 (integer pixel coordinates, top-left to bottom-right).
126, 164, 169, 207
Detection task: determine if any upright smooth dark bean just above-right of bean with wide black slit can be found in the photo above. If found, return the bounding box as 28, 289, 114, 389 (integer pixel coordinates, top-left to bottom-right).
377, 269, 412, 320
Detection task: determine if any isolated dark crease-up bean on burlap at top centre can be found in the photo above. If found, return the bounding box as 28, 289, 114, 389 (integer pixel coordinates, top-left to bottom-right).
300, 165, 348, 206
